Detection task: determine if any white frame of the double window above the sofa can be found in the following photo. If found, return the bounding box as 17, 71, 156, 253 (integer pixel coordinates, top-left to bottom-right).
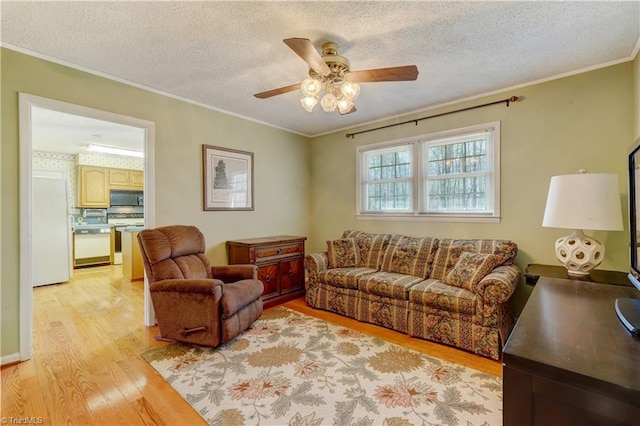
356, 121, 501, 223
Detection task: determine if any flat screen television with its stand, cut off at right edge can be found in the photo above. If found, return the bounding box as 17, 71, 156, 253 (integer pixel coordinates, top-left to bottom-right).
615, 138, 640, 336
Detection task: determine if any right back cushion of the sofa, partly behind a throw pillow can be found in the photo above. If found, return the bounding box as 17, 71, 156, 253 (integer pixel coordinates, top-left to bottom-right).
429, 239, 518, 280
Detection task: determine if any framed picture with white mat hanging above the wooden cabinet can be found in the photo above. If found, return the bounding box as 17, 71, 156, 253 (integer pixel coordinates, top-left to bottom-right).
202, 145, 254, 211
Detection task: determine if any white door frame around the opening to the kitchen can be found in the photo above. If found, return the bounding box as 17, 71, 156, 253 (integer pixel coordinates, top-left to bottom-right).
18, 93, 156, 361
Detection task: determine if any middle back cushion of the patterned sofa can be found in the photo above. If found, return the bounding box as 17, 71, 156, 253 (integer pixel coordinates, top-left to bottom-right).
380, 235, 438, 279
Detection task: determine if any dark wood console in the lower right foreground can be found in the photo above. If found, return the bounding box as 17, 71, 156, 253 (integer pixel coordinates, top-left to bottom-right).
503, 277, 640, 426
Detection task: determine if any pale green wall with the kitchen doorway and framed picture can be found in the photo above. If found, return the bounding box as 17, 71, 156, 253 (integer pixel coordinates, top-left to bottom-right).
0, 49, 309, 356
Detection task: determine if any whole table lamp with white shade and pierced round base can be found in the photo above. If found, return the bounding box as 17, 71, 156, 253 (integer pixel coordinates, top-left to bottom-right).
542, 170, 623, 276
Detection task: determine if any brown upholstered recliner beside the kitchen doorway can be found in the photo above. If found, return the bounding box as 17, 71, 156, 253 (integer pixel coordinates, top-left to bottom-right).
138, 225, 264, 346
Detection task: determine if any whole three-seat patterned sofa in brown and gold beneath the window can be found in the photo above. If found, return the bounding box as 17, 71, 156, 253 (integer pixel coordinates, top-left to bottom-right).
305, 231, 520, 359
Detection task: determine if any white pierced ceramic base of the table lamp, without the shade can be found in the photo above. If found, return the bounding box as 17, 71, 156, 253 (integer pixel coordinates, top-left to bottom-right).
556, 230, 604, 275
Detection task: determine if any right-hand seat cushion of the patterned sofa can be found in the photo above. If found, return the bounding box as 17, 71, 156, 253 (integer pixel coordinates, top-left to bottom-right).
409, 279, 482, 315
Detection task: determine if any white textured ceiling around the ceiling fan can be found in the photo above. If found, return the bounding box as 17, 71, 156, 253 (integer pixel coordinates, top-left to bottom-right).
0, 1, 640, 136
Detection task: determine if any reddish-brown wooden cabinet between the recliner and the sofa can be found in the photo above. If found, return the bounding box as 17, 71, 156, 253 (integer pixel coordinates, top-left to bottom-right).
227, 235, 307, 308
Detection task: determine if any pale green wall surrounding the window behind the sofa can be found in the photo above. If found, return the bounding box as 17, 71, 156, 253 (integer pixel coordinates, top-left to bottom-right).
309, 61, 637, 312
